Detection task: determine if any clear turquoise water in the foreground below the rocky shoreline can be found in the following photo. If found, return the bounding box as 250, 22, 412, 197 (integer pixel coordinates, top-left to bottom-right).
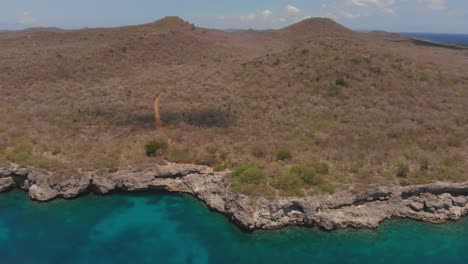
0, 192, 468, 263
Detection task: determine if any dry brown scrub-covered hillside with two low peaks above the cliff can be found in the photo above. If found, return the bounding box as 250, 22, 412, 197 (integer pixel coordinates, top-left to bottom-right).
0, 18, 468, 197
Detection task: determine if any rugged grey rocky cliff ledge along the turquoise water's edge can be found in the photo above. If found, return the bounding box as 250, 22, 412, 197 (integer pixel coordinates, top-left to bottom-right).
0, 163, 468, 230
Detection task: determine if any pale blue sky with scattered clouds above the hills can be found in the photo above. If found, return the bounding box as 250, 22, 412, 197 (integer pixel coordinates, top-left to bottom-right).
0, 0, 468, 34
